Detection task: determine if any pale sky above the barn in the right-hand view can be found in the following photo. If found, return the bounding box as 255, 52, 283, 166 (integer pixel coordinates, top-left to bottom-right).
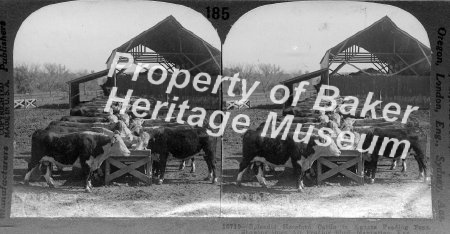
222, 2, 430, 72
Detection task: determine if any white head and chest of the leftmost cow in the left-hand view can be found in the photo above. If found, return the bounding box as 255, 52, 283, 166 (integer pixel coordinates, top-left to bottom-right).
86, 134, 131, 171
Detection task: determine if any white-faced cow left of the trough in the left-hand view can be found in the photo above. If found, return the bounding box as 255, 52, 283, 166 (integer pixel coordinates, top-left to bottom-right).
24, 129, 130, 192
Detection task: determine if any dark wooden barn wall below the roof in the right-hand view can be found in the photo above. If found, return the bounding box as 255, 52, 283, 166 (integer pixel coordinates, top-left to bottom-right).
330, 75, 430, 109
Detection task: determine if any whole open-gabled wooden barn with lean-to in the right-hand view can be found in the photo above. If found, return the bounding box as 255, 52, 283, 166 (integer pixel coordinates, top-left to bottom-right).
282, 16, 431, 109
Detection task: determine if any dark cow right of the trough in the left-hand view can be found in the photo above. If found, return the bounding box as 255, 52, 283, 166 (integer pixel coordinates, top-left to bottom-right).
145, 125, 217, 184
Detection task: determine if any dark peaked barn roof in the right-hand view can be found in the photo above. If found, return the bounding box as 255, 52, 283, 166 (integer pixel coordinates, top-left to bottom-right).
321, 16, 431, 74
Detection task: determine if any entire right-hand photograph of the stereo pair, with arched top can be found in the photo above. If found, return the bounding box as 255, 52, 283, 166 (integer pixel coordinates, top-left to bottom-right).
221, 2, 432, 218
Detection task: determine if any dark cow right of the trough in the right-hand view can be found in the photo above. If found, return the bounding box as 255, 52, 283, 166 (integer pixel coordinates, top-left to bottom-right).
361, 128, 427, 183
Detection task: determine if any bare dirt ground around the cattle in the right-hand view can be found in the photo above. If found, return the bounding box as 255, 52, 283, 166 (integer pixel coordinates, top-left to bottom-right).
221, 109, 432, 218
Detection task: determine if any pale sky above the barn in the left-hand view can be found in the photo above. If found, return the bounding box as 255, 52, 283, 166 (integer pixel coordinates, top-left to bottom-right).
14, 1, 220, 71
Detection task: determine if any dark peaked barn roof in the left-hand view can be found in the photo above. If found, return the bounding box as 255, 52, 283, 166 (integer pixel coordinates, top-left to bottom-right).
107, 15, 221, 73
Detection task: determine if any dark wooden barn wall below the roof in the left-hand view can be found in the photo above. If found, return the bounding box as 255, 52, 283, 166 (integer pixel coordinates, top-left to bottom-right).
110, 73, 220, 110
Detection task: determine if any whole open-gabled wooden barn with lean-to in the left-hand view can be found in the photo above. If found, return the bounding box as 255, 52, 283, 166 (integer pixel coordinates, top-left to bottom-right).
68, 16, 221, 109
